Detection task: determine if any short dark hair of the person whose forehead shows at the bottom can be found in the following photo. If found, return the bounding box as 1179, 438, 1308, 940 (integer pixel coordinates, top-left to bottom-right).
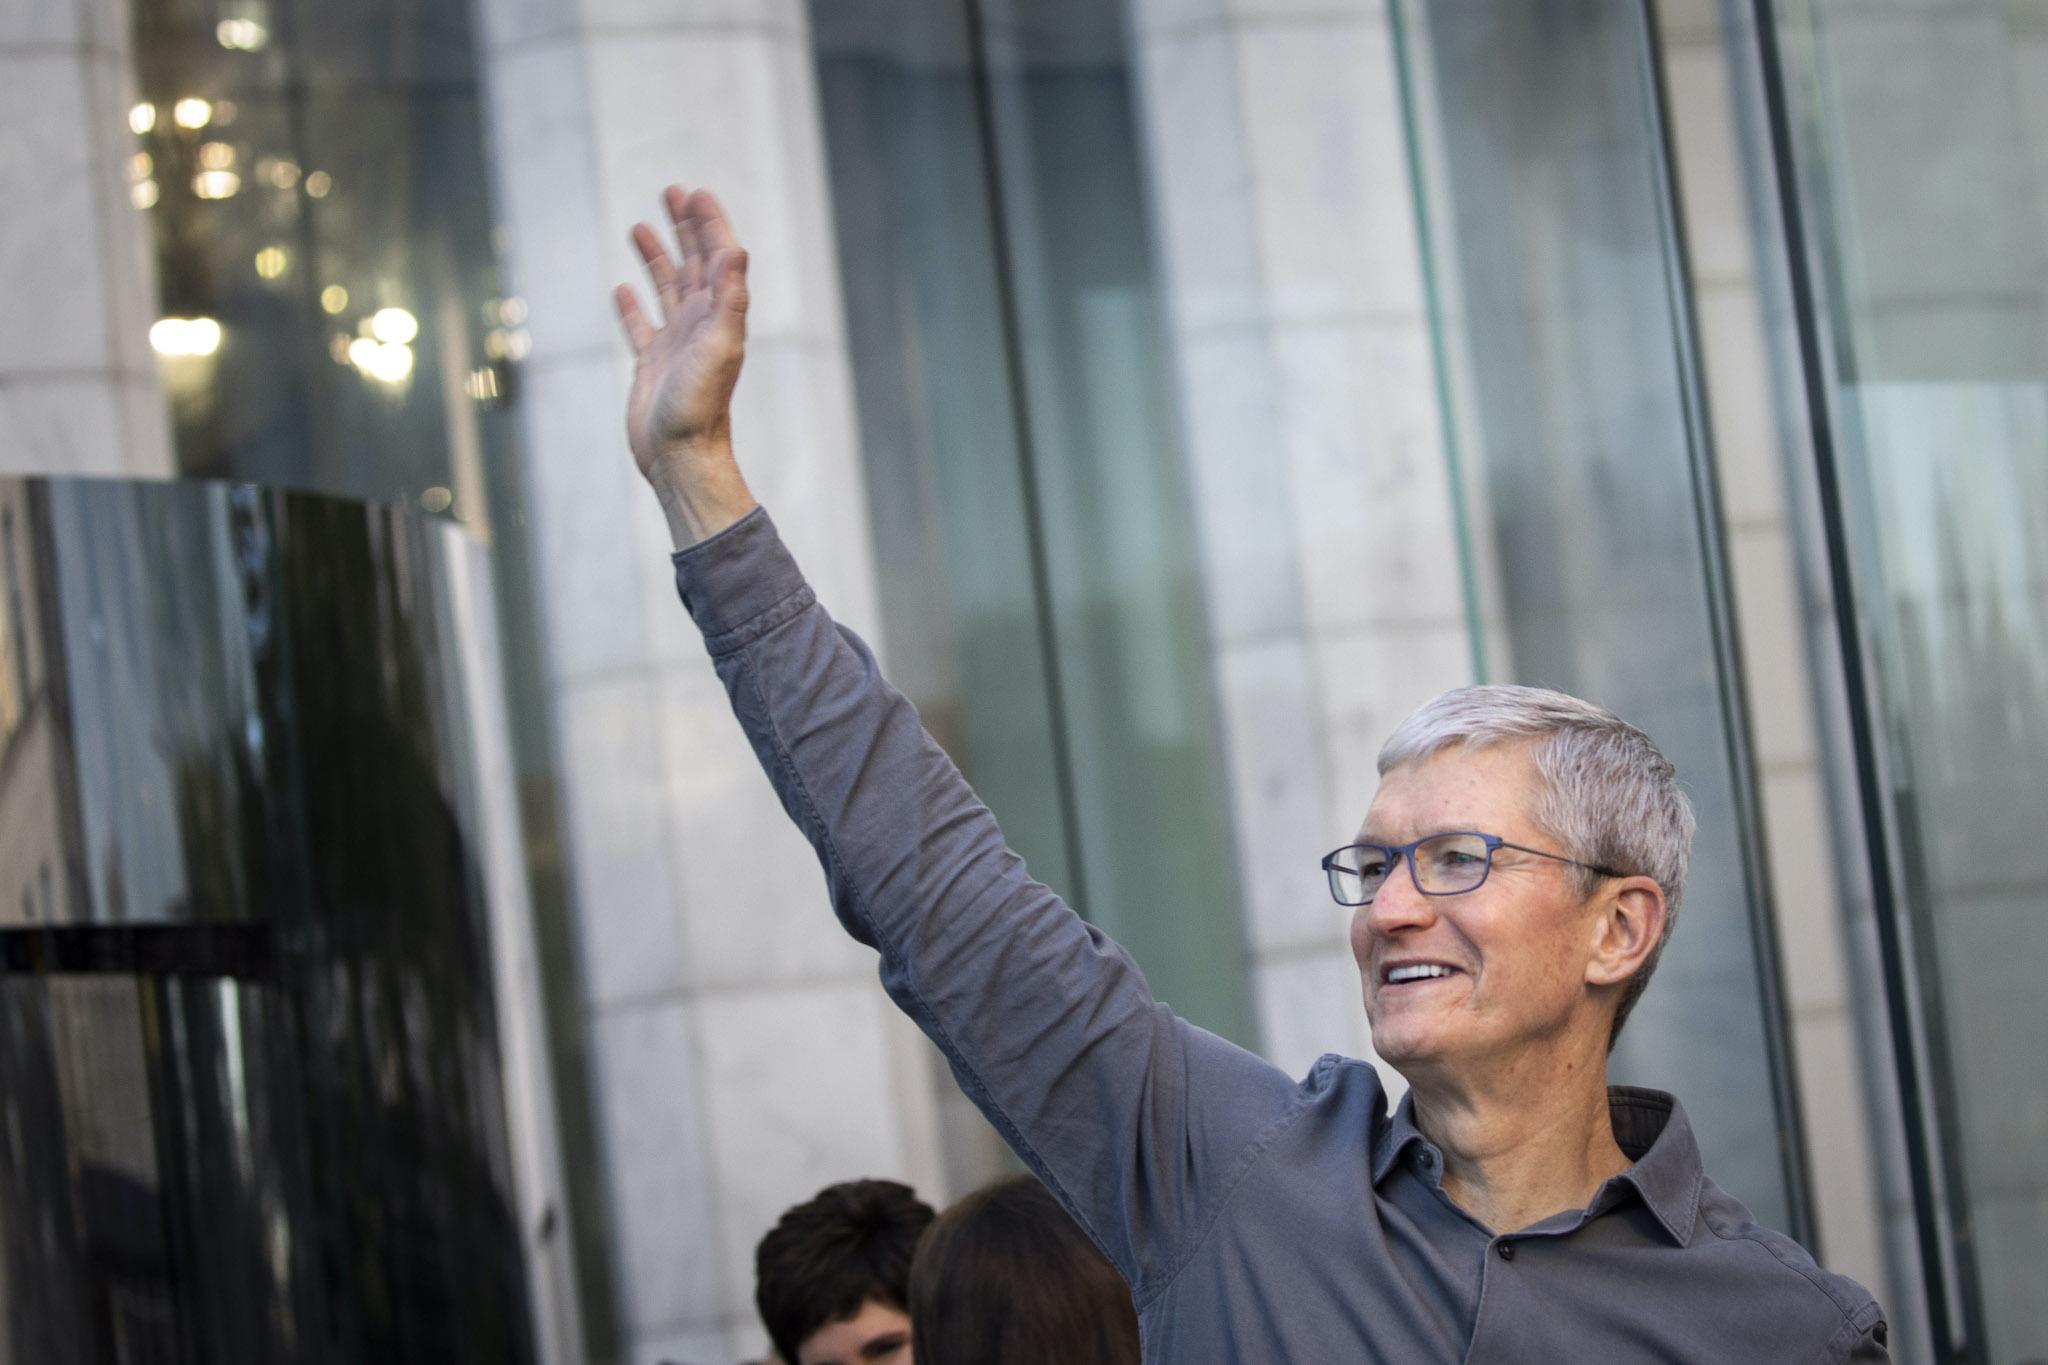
754, 1181, 932, 1365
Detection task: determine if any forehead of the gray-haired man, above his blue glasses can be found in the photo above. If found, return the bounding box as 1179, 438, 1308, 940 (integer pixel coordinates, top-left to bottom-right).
1358, 739, 1542, 843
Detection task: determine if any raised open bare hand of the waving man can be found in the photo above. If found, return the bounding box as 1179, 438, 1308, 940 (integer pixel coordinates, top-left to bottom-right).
612, 184, 752, 544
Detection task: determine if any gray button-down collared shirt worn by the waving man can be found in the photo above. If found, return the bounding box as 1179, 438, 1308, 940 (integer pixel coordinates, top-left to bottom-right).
676, 512, 1886, 1365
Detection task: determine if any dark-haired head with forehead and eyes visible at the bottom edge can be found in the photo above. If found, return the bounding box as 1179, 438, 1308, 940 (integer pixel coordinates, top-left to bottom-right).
754, 1181, 932, 1365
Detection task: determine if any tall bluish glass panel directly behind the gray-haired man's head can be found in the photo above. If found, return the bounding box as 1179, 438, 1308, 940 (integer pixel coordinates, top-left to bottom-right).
1397, 0, 1802, 1232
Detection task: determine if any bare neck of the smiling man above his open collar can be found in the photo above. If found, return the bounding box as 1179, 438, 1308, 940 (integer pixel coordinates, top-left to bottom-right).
1413, 1058, 1630, 1232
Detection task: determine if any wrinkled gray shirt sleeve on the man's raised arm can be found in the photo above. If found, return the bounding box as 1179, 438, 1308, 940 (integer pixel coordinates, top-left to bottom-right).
676, 510, 1298, 1295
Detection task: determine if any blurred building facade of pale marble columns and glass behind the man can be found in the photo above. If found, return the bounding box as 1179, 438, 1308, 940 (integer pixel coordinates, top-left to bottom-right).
0, 0, 2048, 1361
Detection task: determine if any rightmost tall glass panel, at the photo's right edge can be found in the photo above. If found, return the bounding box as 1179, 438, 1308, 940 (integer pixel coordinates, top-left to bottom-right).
1776, 0, 2048, 1361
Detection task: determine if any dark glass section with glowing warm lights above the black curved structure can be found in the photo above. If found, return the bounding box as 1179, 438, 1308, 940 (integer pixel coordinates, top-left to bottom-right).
129, 0, 512, 524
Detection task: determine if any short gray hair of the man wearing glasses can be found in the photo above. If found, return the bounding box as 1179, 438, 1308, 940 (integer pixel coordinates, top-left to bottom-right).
1380, 684, 1696, 1052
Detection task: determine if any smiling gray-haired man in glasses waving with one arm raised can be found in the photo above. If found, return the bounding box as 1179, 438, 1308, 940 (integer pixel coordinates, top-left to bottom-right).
616, 186, 1888, 1365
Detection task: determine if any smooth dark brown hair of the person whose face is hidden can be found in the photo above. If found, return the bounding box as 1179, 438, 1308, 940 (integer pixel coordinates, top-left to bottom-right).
909, 1175, 1139, 1365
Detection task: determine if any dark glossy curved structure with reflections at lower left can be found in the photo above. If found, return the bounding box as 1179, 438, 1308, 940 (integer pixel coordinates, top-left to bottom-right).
0, 481, 532, 1365
